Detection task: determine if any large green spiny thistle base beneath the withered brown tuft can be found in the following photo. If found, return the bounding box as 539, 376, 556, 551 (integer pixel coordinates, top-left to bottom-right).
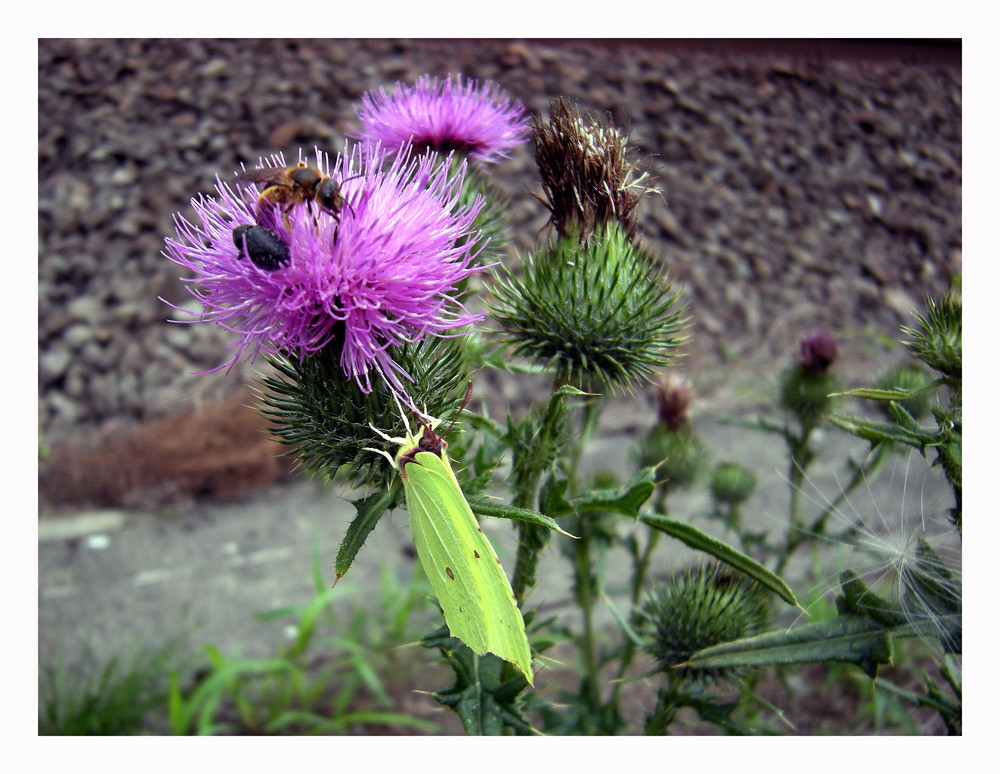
491, 224, 686, 391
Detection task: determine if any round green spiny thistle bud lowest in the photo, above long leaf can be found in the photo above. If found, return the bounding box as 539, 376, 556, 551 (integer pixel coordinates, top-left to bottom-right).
639, 565, 768, 686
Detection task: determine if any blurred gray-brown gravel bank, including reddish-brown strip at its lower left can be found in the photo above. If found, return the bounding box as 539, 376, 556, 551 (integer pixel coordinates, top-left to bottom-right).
38, 40, 962, 504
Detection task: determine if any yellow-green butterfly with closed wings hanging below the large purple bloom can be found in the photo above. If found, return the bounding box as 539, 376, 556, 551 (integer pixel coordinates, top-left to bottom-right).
373, 394, 533, 684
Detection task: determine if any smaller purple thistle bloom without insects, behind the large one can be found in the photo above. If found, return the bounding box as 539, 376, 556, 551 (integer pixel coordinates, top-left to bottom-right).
356, 75, 529, 163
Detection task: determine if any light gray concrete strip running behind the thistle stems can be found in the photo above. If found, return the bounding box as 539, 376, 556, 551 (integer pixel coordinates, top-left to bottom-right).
38, 418, 947, 680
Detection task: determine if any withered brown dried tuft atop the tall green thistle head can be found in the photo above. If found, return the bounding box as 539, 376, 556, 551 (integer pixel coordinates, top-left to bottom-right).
531, 98, 657, 242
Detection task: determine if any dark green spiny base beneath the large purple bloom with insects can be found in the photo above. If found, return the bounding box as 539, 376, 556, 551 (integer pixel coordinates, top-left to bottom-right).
255, 338, 469, 488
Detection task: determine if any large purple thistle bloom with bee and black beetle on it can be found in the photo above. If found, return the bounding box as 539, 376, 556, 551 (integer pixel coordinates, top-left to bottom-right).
164, 145, 485, 403
